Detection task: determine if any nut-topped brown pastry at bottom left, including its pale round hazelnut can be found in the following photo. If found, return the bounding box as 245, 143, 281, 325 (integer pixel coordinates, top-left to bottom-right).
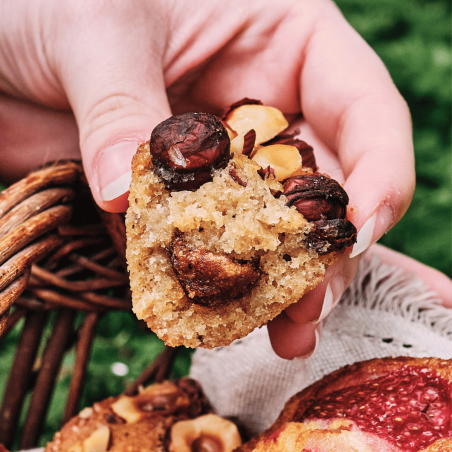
45, 378, 241, 452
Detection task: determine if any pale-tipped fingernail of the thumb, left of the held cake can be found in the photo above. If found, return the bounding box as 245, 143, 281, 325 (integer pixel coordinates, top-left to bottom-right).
96, 141, 138, 201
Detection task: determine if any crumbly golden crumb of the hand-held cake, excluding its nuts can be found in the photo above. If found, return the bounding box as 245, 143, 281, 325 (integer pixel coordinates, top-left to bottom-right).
126, 143, 337, 348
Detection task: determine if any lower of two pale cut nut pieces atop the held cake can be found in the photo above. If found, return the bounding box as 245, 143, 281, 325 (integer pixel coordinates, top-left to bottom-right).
251, 144, 301, 181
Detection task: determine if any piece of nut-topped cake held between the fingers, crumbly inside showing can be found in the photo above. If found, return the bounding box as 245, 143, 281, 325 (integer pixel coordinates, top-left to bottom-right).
126, 99, 356, 348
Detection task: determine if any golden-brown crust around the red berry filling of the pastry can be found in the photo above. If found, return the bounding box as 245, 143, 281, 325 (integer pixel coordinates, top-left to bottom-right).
236, 357, 452, 452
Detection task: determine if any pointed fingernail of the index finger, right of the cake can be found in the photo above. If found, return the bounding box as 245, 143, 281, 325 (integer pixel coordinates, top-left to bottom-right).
350, 204, 394, 257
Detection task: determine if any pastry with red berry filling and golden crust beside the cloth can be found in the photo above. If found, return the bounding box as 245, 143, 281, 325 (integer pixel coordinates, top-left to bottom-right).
237, 357, 452, 452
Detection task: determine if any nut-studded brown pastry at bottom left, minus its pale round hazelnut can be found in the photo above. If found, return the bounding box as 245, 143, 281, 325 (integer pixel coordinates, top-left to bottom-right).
45, 379, 211, 452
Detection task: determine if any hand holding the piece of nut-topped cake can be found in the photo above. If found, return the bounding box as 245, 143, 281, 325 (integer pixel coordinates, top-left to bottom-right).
0, 0, 414, 358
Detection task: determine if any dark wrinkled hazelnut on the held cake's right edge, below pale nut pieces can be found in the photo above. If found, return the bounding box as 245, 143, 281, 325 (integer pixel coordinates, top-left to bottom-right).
284, 173, 348, 221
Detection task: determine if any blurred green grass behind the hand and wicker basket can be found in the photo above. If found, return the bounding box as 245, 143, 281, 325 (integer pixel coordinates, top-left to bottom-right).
0, 0, 452, 444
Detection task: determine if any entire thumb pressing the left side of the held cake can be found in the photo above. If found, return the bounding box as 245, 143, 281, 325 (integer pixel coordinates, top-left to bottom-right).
53, 4, 171, 212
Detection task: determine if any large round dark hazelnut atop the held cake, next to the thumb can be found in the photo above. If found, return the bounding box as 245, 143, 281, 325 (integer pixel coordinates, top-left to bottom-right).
149, 113, 230, 191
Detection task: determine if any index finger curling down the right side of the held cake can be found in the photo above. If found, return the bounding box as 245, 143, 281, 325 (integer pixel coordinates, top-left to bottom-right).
300, 0, 415, 256
